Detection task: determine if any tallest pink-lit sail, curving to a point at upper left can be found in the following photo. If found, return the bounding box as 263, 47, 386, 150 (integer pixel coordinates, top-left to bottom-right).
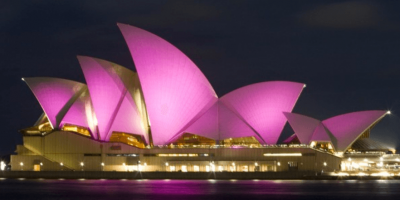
118, 24, 217, 145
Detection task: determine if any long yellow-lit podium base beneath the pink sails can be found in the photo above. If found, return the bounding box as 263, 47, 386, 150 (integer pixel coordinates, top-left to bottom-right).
11, 131, 341, 172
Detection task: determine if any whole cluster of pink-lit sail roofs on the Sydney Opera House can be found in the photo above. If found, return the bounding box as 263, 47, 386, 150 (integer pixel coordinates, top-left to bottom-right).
22, 24, 390, 151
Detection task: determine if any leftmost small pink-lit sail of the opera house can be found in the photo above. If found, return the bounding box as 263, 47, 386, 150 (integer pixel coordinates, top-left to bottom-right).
23, 77, 86, 128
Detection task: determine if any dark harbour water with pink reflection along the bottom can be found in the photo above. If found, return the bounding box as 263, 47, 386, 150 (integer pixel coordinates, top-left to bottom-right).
0, 179, 400, 200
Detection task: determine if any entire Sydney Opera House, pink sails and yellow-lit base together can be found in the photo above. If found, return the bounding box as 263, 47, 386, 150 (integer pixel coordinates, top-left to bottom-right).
11, 24, 389, 172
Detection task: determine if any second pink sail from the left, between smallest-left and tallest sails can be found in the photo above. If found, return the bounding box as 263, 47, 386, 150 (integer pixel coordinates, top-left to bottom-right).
78, 56, 148, 142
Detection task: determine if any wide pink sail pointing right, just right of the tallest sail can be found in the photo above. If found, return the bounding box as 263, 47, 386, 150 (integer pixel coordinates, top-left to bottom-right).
221, 81, 304, 144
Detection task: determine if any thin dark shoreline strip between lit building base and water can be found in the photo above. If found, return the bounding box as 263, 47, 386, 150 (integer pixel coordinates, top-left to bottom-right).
0, 171, 400, 180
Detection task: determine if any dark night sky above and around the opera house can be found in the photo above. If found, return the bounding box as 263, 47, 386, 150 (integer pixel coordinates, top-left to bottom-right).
0, 0, 400, 155
